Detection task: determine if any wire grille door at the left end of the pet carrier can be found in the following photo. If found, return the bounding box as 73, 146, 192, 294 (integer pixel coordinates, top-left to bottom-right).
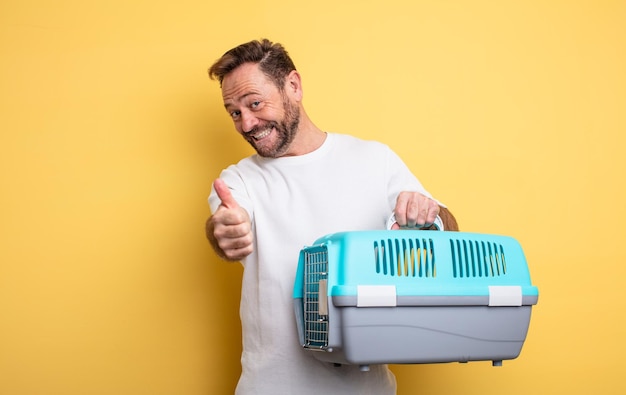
304, 246, 328, 349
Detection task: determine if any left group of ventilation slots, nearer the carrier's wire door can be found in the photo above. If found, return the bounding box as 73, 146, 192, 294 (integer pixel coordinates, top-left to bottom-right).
374, 239, 437, 277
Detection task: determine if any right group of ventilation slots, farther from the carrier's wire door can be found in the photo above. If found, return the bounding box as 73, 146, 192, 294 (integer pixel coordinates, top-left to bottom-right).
450, 240, 506, 277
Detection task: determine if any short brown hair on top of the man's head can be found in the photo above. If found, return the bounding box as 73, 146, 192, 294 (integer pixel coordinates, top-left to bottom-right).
209, 38, 296, 90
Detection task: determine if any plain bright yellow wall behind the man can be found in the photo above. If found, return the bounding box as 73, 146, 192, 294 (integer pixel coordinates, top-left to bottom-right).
0, 0, 626, 395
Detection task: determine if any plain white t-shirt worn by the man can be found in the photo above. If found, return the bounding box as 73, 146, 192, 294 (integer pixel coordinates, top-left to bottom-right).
209, 133, 430, 395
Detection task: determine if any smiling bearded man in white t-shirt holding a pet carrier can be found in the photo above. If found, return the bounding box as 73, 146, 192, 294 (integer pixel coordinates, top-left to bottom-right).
206, 40, 457, 395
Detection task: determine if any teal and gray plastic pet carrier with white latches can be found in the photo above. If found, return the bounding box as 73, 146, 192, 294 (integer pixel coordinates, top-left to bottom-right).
294, 230, 538, 370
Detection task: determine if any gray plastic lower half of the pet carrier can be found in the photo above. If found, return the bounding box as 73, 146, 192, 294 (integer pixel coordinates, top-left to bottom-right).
292, 298, 531, 370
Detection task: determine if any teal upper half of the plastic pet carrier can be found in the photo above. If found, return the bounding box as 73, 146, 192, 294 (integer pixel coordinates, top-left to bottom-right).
294, 230, 538, 306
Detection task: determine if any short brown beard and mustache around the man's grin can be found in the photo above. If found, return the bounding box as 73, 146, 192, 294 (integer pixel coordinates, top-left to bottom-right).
244, 97, 300, 158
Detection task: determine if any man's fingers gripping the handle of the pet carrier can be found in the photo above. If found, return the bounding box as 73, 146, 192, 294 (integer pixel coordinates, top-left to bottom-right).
394, 192, 439, 228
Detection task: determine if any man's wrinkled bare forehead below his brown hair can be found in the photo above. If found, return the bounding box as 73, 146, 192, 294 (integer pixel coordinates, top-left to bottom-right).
222, 63, 276, 105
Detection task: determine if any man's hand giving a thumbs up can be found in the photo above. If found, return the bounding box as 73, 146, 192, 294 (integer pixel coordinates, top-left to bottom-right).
206, 178, 253, 261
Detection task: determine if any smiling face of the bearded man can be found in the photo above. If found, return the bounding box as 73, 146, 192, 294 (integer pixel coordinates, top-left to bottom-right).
222, 63, 300, 158
